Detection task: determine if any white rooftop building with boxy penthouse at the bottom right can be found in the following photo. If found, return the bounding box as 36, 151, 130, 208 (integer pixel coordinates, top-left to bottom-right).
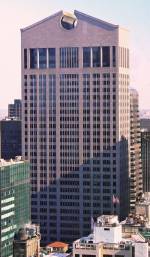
73, 215, 148, 257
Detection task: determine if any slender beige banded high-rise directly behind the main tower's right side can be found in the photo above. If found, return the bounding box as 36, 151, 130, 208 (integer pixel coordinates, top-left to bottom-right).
130, 89, 143, 212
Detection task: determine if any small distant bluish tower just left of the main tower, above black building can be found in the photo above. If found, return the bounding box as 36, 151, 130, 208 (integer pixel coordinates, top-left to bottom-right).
8, 99, 22, 120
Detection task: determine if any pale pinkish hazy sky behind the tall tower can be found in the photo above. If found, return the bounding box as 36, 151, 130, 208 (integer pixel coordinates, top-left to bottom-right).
0, 0, 150, 109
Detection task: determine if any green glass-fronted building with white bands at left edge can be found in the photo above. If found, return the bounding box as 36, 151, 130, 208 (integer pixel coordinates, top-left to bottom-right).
0, 158, 30, 257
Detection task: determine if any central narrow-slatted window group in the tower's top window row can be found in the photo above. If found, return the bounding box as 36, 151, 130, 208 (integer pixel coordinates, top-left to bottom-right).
60, 47, 79, 68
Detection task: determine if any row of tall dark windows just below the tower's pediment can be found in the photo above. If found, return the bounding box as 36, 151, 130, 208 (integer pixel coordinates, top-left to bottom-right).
24, 46, 120, 69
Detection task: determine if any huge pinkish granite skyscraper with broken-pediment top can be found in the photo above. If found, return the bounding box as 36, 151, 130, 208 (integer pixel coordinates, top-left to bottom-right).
21, 11, 130, 243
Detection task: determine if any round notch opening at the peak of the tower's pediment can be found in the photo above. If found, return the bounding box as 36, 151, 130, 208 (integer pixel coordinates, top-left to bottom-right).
61, 13, 77, 30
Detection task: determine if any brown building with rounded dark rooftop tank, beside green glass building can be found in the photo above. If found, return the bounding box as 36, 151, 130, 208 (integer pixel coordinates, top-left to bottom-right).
13, 224, 40, 257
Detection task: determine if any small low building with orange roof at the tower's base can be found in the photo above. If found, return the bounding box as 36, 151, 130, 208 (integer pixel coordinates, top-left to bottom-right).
46, 241, 68, 253
